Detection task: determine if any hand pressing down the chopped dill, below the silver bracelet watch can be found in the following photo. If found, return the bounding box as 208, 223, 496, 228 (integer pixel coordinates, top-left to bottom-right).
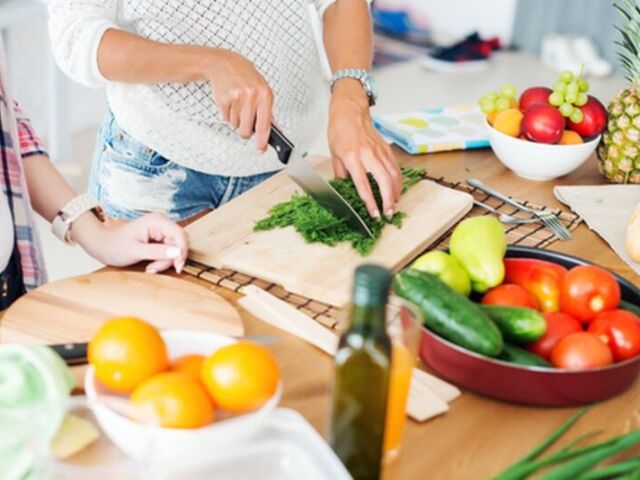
329, 79, 402, 218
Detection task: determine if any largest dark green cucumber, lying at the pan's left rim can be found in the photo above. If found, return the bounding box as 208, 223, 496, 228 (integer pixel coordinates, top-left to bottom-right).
394, 269, 502, 357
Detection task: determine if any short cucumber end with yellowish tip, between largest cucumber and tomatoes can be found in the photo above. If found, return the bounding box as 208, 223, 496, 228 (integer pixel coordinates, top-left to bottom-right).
482, 305, 547, 344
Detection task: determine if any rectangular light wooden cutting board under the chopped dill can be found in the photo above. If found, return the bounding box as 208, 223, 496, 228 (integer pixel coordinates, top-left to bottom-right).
187, 157, 473, 307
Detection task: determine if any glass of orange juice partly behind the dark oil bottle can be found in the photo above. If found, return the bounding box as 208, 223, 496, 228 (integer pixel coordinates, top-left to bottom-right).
383, 297, 422, 463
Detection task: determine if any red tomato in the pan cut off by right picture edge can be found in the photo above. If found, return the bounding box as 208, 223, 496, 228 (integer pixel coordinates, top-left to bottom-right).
589, 310, 640, 362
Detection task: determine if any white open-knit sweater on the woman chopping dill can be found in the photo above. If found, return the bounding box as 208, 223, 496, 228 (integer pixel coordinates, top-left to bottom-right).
48, 0, 335, 176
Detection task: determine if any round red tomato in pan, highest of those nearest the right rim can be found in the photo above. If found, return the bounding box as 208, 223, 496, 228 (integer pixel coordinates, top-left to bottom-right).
560, 265, 620, 323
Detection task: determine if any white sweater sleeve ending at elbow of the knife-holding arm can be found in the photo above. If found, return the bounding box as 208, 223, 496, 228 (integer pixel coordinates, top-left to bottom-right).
47, 0, 118, 88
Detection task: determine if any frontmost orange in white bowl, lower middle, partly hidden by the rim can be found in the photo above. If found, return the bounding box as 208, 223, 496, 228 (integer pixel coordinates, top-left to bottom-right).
130, 372, 215, 428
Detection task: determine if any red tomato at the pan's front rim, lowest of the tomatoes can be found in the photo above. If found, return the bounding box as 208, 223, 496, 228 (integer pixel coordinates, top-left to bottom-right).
551, 332, 613, 370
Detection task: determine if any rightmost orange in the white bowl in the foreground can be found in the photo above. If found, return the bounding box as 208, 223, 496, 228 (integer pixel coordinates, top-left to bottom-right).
200, 342, 280, 413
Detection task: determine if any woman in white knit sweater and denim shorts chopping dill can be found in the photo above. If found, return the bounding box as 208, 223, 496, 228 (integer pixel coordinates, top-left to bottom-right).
48, 0, 402, 221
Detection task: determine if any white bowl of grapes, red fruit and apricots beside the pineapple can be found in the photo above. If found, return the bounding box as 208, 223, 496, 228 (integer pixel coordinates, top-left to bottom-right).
479, 71, 607, 180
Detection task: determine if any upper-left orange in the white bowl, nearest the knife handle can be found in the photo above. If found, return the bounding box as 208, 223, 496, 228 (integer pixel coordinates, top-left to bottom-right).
88, 317, 169, 393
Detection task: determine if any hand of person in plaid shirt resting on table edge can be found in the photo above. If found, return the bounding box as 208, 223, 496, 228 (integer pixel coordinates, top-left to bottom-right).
74, 213, 189, 273
